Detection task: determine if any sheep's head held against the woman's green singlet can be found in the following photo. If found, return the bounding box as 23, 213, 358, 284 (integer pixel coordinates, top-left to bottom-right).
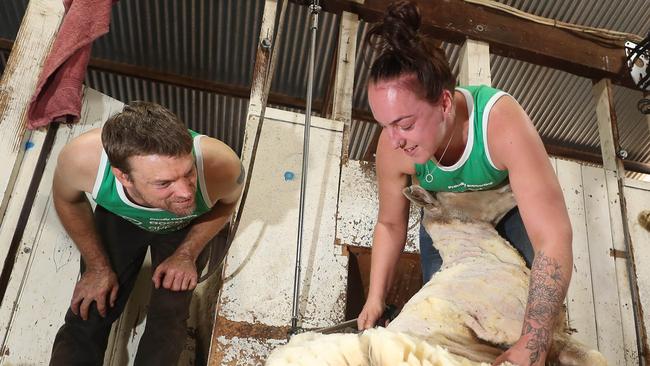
402, 185, 517, 225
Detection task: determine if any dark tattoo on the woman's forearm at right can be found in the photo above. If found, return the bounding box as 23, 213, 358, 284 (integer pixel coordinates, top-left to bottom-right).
522, 252, 565, 364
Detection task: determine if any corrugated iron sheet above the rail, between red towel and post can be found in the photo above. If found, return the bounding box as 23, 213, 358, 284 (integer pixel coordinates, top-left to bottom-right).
93, 0, 264, 85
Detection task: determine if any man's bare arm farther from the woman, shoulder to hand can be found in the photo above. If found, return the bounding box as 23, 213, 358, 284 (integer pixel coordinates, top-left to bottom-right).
52, 131, 118, 320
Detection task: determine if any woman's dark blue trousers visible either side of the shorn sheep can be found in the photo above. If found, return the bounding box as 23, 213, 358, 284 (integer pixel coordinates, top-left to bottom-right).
420, 207, 535, 283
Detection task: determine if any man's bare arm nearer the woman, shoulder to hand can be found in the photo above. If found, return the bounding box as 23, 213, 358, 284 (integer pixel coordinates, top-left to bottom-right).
153, 137, 244, 291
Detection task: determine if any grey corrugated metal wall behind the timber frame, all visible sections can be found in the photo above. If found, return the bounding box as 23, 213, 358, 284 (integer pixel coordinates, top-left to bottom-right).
0, 0, 650, 172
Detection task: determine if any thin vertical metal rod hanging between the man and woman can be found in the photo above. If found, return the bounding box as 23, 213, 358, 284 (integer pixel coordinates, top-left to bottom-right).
289, 0, 321, 335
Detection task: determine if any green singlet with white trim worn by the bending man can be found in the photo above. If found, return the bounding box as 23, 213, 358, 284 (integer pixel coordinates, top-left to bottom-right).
92, 130, 212, 233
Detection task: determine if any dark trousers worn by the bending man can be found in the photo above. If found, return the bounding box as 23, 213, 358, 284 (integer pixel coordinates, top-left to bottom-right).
50, 206, 207, 366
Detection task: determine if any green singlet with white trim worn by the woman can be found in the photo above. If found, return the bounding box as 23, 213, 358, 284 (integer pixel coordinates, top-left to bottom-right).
415, 85, 508, 192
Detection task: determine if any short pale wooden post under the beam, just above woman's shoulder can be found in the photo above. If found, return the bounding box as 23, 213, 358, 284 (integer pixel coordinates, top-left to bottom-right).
458, 39, 492, 86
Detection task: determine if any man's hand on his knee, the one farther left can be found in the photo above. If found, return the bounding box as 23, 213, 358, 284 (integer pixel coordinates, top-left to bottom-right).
70, 267, 119, 320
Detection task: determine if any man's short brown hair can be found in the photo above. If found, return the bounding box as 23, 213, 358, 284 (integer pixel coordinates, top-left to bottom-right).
102, 101, 192, 174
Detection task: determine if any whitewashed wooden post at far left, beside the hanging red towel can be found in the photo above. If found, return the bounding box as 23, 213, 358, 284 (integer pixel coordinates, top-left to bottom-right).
0, 0, 64, 305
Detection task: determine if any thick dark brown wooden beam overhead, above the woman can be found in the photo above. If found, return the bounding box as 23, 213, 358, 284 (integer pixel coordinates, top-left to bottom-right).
290, 0, 634, 88
